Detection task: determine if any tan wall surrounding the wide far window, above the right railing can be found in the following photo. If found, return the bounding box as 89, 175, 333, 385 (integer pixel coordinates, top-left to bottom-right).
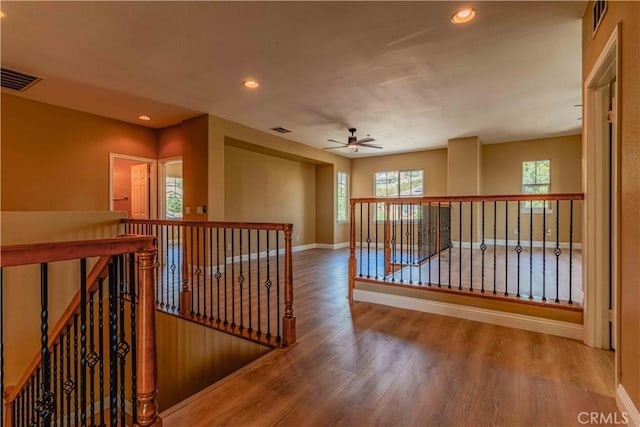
351, 149, 447, 197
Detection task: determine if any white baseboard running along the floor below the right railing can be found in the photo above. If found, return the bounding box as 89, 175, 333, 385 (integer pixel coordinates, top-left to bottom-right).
353, 289, 583, 340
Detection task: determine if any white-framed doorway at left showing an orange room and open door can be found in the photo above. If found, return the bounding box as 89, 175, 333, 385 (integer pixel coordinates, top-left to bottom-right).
109, 153, 158, 219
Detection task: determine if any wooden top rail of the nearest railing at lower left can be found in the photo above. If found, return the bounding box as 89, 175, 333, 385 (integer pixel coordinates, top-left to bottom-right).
0, 235, 155, 267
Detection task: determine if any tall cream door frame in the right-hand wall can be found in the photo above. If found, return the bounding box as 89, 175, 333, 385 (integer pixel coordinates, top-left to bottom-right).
582, 24, 620, 358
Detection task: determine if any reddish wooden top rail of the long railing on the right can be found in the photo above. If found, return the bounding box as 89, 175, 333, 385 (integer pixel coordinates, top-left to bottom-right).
351, 193, 584, 204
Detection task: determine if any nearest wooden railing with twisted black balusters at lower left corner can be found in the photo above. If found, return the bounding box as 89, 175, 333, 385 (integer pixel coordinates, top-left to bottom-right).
0, 236, 162, 427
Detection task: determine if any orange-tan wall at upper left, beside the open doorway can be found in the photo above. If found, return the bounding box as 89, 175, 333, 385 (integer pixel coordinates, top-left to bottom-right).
1, 93, 157, 211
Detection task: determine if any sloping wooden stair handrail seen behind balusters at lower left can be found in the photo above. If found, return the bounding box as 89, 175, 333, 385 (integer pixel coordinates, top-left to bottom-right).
4, 255, 111, 404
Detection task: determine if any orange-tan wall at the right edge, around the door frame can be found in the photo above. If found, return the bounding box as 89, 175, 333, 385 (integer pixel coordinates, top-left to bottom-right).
582, 1, 640, 408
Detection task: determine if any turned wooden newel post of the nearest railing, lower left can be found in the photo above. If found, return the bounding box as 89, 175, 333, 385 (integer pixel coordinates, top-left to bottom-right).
135, 249, 162, 427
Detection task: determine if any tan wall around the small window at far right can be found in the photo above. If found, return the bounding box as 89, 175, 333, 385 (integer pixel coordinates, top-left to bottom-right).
481, 135, 583, 242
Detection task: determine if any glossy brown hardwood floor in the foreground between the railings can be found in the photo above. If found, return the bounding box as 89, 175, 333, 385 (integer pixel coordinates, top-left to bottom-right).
159, 249, 617, 427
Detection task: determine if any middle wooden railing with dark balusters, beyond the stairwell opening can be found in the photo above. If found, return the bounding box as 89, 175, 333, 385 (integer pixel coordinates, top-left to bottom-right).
122, 219, 296, 347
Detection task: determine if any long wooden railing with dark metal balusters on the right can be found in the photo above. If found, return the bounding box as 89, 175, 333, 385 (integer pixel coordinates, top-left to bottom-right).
349, 193, 583, 310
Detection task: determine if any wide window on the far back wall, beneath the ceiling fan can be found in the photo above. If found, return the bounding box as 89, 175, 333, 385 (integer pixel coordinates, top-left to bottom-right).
375, 169, 423, 221
